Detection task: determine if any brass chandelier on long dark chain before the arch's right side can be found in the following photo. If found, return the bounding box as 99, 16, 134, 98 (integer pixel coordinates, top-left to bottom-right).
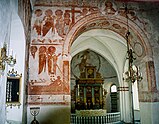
123, 5, 142, 124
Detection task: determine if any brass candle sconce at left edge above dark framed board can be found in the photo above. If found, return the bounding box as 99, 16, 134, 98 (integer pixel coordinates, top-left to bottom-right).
0, 44, 16, 73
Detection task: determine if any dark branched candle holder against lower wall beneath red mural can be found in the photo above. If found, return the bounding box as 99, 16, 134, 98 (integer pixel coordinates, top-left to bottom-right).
30, 107, 40, 124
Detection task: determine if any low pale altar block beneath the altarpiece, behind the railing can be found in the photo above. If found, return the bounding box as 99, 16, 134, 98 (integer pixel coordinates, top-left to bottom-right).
76, 109, 106, 117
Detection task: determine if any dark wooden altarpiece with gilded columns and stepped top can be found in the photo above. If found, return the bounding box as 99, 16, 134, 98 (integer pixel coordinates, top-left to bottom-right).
75, 66, 104, 110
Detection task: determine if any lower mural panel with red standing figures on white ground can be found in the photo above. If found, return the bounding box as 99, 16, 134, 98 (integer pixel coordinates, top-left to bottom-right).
28, 45, 64, 95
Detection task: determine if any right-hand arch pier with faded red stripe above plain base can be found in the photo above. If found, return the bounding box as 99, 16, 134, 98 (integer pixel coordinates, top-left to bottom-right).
139, 60, 159, 124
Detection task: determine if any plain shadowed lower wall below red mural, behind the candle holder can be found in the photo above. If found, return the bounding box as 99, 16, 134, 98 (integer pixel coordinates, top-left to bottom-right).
27, 104, 70, 124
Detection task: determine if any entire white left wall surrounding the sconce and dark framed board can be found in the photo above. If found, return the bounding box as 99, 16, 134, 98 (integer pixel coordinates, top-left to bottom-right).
0, 0, 25, 124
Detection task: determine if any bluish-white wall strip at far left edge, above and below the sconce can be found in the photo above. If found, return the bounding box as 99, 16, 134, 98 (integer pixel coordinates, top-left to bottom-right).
0, 0, 11, 124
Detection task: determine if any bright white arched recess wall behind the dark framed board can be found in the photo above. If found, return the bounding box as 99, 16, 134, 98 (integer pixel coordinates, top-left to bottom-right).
7, 13, 25, 124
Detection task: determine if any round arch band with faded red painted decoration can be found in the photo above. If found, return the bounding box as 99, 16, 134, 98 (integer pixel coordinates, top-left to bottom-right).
63, 13, 153, 60
